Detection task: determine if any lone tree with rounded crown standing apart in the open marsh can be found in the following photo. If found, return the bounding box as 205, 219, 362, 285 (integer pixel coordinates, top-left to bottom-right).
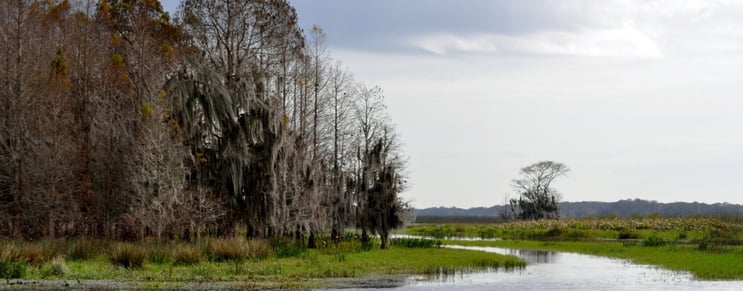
508, 161, 570, 220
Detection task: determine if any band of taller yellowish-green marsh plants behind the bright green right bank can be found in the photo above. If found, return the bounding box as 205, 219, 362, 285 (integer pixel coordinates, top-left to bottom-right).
405, 217, 743, 245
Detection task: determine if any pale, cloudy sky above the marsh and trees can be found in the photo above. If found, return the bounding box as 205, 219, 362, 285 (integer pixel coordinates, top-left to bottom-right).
163, 0, 743, 208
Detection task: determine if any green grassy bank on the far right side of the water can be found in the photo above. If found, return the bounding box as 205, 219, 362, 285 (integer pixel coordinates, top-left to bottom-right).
408, 217, 743, 280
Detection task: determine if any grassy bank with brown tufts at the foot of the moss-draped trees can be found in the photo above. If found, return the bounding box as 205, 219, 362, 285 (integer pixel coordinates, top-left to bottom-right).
0, 239, 524, 288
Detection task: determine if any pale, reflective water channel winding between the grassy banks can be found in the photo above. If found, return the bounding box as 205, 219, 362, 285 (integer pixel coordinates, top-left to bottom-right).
322, 246, 743, 291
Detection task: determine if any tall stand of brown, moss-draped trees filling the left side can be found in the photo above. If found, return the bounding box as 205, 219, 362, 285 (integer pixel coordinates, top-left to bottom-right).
0, 0, 410, 247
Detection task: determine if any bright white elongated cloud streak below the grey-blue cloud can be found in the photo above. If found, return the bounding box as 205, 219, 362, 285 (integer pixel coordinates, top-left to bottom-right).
409, 26, 662, 57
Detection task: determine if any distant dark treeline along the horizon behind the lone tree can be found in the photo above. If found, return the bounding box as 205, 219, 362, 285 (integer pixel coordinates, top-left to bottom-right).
416, 199, 743, 223
